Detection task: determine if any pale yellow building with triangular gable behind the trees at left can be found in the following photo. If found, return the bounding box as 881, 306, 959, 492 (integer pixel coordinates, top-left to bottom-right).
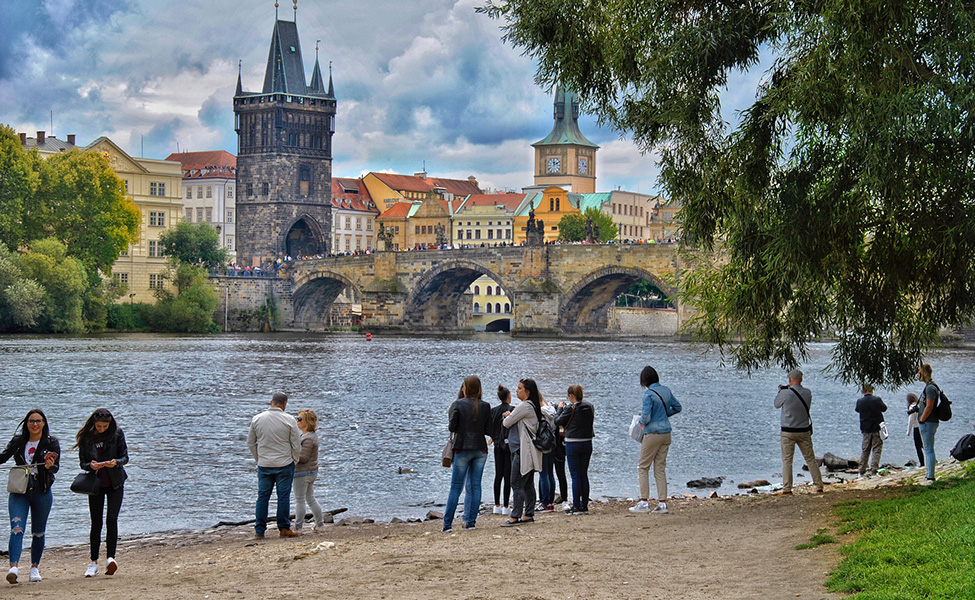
86, 137, 183, 303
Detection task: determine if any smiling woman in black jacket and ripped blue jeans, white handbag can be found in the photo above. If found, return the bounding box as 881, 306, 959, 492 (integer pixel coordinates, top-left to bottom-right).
0, 408, 61, 583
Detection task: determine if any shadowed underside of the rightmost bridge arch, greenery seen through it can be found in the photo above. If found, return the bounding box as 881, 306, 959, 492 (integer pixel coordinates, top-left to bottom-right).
559, 266, 676, 333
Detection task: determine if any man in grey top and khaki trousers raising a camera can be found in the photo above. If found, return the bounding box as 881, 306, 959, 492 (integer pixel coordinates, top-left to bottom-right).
775, 369, 823, 496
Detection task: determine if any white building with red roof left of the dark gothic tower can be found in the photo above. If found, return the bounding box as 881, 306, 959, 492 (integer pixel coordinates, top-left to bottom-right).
166, 150, 237, 262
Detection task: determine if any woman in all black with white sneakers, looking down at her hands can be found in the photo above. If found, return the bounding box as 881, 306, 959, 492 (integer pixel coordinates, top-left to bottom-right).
74, 408, 129, 577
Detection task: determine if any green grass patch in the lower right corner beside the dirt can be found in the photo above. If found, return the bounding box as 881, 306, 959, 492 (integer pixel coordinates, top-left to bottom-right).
826, 472, 975, 600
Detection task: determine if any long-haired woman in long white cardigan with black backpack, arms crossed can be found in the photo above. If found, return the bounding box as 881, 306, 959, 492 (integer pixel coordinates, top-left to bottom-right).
501, 379, 543, 527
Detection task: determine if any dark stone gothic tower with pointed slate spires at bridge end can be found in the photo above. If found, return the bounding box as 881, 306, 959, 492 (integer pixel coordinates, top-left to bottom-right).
234, 2, 335, 265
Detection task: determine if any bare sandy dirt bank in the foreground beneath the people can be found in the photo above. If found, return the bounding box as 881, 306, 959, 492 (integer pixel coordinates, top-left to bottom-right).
7, 485, 904, 600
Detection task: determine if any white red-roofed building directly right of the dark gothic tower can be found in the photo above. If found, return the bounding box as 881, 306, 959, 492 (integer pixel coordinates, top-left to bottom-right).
332, 177, 379, 254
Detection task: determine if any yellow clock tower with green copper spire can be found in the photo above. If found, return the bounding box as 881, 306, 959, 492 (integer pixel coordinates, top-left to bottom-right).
532, 85, 599, 194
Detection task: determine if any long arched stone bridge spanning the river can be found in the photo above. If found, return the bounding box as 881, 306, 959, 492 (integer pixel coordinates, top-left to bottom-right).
213, 244, 684, 335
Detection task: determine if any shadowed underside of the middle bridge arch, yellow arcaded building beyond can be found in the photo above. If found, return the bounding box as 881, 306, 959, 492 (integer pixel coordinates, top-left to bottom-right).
403, 259, 514, 331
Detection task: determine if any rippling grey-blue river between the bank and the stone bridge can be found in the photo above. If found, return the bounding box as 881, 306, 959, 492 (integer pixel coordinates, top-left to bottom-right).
0, 334, 975, 544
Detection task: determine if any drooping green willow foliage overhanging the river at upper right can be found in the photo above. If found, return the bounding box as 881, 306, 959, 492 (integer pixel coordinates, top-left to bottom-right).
480, 0, 975, 383
